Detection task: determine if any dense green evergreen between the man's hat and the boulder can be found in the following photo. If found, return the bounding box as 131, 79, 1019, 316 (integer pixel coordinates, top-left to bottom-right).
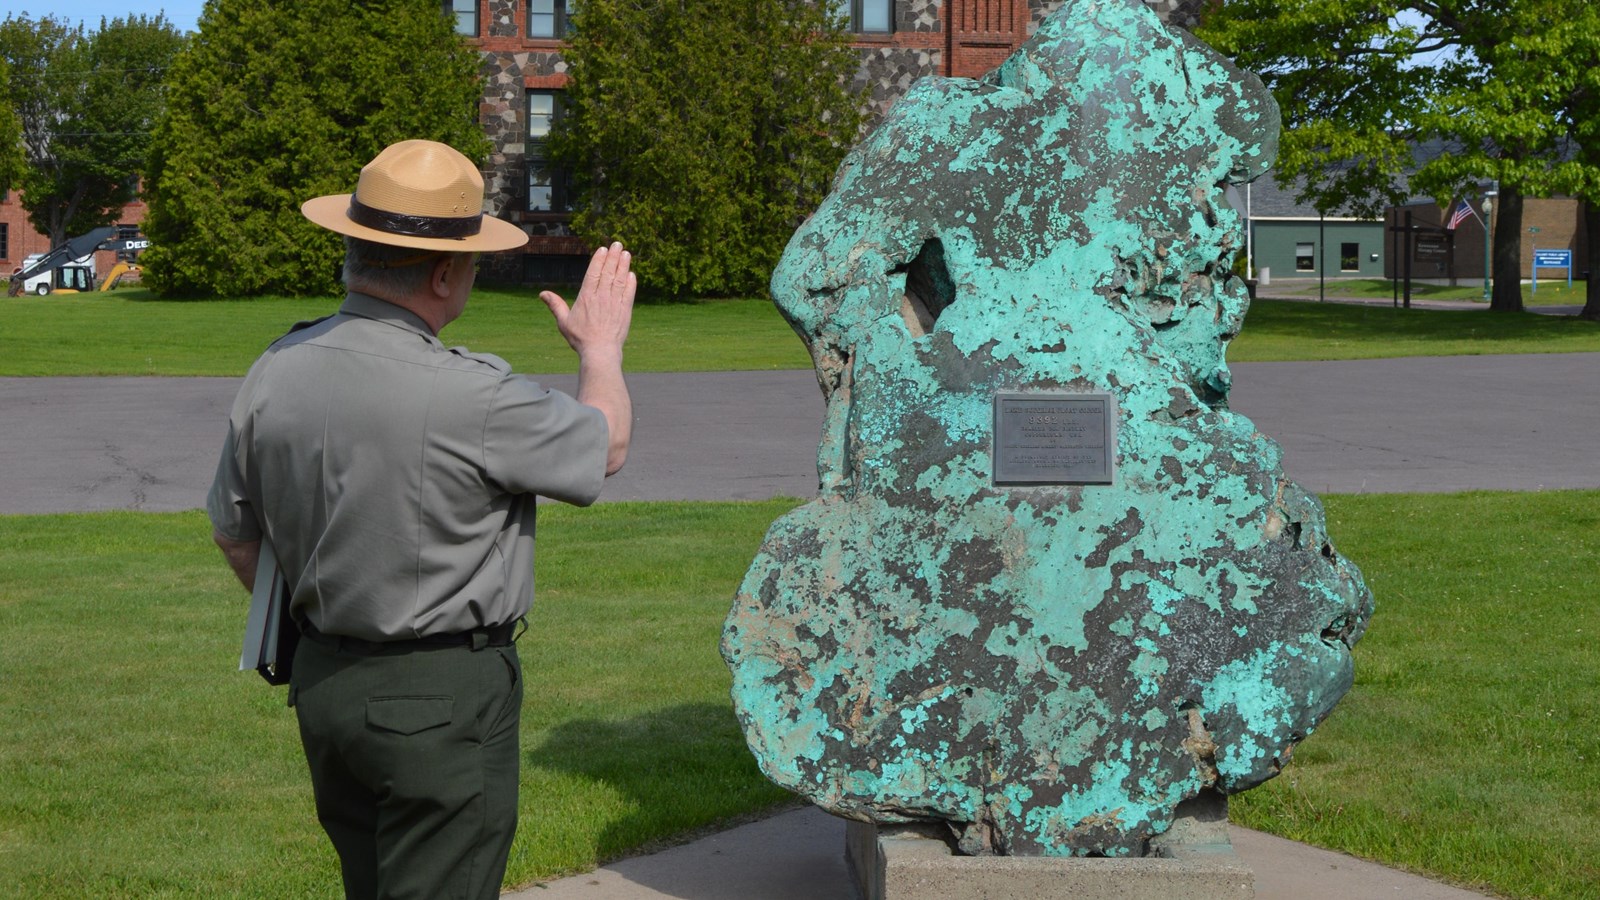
552, 0, 862, 296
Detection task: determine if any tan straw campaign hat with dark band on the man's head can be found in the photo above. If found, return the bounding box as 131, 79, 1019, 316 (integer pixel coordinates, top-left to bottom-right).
301, 141, 528, 253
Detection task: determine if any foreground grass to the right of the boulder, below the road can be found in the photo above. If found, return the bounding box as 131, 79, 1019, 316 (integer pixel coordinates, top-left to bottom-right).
1232, 492, 1600, 898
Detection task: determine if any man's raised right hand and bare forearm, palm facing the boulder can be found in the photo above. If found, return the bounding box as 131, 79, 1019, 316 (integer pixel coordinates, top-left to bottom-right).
539, 243, 638, 476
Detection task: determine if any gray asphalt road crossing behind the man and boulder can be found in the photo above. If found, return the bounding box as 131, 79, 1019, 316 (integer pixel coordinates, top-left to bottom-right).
0, 354, 1600, 514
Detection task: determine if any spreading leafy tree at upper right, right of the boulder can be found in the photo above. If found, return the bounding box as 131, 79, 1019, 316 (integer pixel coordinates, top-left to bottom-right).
1200, 0, 1600, 311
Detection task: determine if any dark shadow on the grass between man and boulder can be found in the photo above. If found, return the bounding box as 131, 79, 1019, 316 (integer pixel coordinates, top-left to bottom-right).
523, 703, 794, 860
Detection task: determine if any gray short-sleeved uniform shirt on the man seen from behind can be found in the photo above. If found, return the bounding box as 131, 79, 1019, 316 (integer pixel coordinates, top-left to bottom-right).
206, 293, 608, 641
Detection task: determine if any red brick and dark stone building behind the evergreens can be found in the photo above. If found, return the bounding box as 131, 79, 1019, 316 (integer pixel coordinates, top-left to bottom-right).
445, 0, 1210, 282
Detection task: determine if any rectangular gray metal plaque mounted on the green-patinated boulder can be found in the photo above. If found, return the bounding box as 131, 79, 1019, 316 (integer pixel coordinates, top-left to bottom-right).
994, 392, 1117, 485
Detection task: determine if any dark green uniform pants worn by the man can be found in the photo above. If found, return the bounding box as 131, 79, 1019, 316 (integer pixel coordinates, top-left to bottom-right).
290, 636, 522, 900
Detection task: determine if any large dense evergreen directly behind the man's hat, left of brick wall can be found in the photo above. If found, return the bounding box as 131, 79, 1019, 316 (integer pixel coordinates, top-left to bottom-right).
144, 0, 488, 296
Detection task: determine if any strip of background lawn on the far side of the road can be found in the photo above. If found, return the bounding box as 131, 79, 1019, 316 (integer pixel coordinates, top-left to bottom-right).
0, 288, 1600, 376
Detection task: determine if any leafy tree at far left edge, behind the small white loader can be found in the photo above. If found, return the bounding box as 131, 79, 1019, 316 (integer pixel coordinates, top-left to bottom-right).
0, 16, 184, 245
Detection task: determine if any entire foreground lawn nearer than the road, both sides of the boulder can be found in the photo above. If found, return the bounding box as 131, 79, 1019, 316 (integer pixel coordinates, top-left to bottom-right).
0, 492, 1600, 898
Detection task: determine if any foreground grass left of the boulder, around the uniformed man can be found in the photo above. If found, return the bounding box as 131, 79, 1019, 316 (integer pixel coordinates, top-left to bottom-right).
0, 501, 792, 898
